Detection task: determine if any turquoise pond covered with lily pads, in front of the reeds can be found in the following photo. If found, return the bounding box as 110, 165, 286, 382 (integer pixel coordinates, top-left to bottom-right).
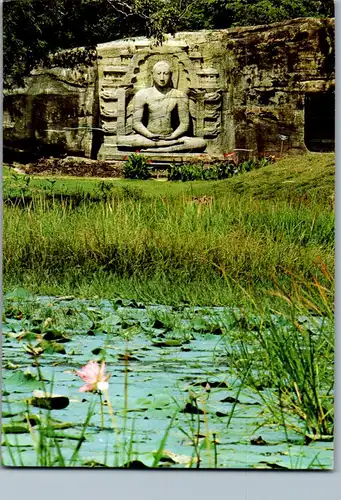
2, 294, 333, 469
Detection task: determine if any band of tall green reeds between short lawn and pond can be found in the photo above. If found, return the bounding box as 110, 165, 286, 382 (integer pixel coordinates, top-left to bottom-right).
3, 190, 334, 304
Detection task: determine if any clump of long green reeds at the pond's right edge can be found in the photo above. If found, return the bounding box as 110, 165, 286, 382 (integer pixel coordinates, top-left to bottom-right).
224, 262, 334, 440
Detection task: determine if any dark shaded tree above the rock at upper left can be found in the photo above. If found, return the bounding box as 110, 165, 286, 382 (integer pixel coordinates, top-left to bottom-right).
3, 0, 164, 86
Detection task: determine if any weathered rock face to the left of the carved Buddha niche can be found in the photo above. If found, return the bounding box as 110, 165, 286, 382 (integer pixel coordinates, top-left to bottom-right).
3, 67, 98, 156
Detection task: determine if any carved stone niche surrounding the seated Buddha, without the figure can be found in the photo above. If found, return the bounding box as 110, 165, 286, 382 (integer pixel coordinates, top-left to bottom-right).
95, 41, 222, 160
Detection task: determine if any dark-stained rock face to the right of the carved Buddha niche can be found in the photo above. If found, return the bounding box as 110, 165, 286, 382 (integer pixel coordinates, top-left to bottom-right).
222, 19, 335, 151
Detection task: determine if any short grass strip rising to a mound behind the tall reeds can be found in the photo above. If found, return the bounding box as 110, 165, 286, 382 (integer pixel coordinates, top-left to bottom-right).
3, 153, 335, 200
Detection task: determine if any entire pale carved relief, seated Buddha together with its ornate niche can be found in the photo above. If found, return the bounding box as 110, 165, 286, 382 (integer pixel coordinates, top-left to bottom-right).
95, 40, 223, 158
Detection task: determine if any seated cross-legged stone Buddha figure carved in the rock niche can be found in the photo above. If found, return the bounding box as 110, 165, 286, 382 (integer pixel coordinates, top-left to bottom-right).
117, 61, 206, 153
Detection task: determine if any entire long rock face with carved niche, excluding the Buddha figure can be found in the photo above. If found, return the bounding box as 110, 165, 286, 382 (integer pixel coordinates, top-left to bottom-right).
4, 18, 335, 160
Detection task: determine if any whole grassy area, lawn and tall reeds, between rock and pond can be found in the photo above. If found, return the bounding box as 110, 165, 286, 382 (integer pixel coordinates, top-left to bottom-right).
3, 154, 334, 305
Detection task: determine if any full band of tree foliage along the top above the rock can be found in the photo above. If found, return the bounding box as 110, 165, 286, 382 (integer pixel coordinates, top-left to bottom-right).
3, 0, 334, 87
